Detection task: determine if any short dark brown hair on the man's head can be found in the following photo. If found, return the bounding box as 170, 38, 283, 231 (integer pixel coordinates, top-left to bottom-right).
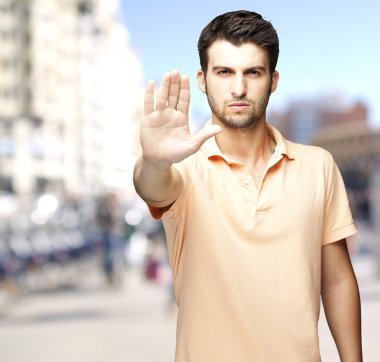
198, 10, 279, 73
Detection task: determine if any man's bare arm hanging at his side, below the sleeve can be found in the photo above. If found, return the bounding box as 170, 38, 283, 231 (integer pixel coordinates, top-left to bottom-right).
321, 239, 363, 362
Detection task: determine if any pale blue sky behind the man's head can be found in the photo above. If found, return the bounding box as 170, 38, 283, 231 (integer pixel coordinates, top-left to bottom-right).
122, 0, 380, 128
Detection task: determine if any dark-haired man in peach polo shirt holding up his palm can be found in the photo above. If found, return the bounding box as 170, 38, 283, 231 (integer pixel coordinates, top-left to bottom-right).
134, 11, 362, 362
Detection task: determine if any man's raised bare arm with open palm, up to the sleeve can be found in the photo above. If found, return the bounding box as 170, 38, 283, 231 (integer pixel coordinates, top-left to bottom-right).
133, 70, 221, 207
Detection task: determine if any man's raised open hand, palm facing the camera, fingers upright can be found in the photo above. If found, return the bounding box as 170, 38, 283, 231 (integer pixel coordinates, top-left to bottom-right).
140, 70, 221, 168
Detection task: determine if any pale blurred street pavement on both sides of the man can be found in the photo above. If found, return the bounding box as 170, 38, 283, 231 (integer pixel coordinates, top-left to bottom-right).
0, 230, 380, 362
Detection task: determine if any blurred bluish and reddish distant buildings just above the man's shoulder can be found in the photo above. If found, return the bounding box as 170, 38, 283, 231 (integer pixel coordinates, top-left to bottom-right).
270, 95, 368, 144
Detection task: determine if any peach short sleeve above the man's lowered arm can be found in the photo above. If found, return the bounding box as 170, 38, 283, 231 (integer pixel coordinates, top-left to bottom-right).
322, 155, 357, 244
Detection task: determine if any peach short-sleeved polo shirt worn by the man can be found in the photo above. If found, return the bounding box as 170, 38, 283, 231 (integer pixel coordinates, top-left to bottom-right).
150, 125, 356, 362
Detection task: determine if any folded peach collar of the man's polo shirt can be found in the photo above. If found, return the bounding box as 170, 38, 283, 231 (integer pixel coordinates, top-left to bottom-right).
201, 121, 294, 164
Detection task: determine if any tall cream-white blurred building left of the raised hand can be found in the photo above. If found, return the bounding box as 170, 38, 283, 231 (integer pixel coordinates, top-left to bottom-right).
0, 0, 142, 204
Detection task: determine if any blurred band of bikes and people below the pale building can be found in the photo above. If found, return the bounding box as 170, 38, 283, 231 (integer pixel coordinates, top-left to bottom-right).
0, 192, 166, 293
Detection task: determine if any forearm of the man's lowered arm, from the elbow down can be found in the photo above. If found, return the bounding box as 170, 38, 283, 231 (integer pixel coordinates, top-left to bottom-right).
322, 272, 363, 362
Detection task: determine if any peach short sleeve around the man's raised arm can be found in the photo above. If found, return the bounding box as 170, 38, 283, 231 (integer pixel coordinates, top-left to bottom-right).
148, 162, 191, 220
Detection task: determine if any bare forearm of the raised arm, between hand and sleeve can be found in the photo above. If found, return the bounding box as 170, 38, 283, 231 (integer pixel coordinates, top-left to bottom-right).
133, 157, 183, 207
